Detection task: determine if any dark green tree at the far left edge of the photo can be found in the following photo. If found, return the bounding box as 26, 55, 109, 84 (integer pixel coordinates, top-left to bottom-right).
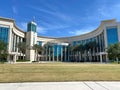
0, 41, 8, 62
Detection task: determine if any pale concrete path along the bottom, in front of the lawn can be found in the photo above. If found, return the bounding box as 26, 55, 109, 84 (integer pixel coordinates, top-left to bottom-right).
0, 81, 120, 90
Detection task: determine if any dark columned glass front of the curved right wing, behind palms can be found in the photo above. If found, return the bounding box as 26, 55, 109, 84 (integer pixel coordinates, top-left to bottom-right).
70, 31, 105, 61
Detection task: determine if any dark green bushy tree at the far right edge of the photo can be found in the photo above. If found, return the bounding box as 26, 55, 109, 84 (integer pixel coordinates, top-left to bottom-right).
107, 43, 120, 64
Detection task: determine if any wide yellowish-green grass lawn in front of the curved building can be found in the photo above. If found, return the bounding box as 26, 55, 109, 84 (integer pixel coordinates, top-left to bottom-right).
0, 63, 120, 82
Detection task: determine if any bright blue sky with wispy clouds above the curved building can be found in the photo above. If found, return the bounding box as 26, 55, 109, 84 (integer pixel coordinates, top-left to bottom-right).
0, 0, 120, 37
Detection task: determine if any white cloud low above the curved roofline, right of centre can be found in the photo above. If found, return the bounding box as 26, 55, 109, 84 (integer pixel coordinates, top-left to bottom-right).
69, 27, 95, 35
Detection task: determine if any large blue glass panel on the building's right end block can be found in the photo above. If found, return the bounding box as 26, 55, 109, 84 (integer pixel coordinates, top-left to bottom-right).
107, 27, 118, 45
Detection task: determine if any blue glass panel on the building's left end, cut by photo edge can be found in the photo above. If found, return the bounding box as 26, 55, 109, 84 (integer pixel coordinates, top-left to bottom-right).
0, 27, 9, 43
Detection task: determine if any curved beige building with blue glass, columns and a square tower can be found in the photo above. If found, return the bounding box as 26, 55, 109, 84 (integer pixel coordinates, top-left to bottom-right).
0, 17, 120, 62
